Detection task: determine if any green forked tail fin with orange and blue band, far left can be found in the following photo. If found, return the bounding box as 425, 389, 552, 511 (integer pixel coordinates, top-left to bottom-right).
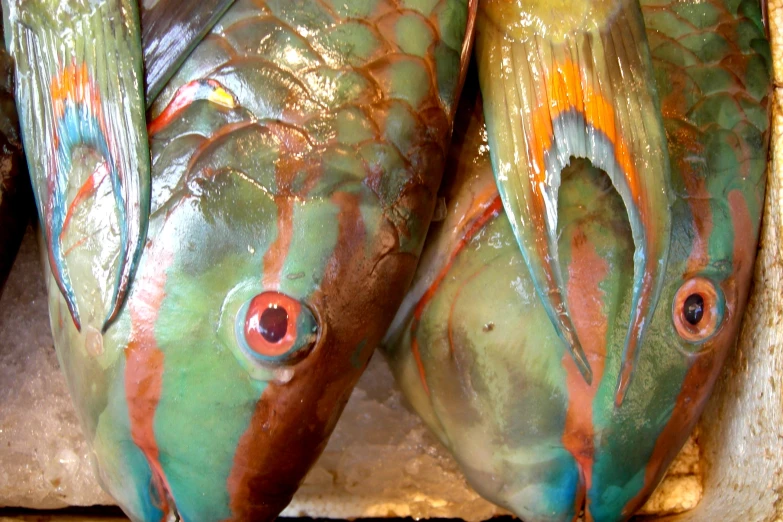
3, 0, 150, 329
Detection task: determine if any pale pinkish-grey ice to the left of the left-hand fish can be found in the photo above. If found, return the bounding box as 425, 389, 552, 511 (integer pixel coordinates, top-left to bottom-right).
0, 225, 111, 509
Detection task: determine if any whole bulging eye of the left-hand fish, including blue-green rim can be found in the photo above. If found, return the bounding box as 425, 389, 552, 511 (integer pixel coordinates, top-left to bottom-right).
235, 292, 318, 364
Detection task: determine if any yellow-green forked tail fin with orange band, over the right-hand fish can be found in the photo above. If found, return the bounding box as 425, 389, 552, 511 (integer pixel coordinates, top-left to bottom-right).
476, 0, 671, 398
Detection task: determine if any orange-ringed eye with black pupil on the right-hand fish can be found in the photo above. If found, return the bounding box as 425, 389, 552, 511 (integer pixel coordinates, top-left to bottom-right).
672, 277, 724, 343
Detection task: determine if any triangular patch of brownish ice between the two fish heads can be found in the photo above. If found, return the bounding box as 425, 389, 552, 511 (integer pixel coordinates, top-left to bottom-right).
283, 353, 505, 520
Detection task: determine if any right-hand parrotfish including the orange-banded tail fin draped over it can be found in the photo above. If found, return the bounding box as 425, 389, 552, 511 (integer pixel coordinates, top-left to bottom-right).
384, 0, 771, 522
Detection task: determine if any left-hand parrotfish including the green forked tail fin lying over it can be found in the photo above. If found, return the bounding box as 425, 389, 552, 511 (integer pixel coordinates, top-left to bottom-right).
4, 0, 476, 522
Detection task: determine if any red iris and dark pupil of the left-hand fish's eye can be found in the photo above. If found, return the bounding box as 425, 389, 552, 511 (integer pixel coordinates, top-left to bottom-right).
244, 292, 302, 357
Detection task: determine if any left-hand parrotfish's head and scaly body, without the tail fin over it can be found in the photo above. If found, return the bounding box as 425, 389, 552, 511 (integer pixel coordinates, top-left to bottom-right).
41, 0, 475, 520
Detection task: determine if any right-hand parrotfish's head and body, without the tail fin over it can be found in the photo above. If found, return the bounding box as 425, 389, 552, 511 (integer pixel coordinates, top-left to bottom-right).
384, 0, 771, 522
